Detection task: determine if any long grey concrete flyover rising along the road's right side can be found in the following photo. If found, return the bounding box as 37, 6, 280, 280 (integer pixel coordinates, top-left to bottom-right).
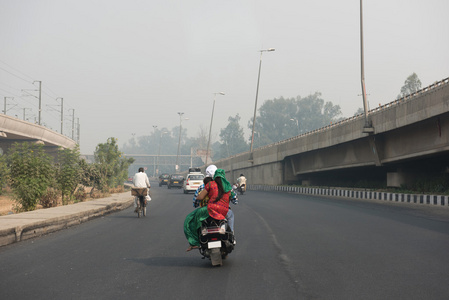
215, 78, 449, 186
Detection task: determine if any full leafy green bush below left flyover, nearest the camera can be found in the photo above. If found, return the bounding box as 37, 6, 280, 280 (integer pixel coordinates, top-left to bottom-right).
7, 142, 54, 211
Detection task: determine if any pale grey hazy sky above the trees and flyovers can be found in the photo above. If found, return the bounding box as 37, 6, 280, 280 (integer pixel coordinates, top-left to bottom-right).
0, 0, 449, 154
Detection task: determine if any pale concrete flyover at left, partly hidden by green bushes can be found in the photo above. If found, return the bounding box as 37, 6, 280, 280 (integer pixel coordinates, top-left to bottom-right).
0, 114, 76, 155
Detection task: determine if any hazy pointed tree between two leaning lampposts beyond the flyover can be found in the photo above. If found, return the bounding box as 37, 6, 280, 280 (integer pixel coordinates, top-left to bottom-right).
218, 114, 249, 159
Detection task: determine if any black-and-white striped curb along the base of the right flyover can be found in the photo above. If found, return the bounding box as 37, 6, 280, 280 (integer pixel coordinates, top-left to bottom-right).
248, 185, 449, 207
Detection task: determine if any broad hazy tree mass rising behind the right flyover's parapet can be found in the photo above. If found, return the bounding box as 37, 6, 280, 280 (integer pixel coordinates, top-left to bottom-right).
248, 92, 341, 146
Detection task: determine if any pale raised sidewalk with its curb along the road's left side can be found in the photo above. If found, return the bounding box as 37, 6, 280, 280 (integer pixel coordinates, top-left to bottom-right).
0, 191, 133, 247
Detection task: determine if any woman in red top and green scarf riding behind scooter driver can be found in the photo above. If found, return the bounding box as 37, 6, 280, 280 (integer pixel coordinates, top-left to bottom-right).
184, 169, 232, 251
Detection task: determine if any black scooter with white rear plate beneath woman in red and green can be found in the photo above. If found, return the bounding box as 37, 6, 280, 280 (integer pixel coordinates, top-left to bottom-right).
198, 217, 235, 266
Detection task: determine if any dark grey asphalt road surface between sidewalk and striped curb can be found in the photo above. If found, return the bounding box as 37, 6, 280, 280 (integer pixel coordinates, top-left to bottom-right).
0, 184, 449, 300
